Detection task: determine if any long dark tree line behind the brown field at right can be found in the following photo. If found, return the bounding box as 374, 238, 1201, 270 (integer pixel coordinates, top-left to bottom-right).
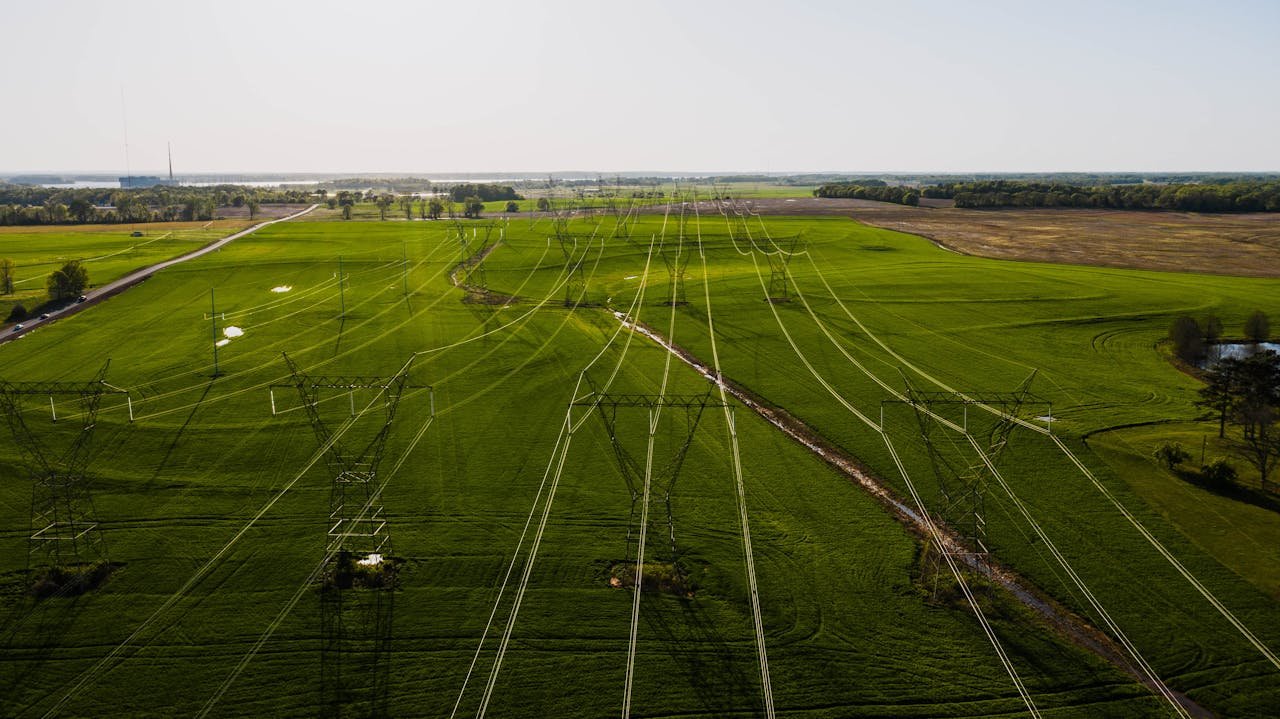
922, 179, 1280, 212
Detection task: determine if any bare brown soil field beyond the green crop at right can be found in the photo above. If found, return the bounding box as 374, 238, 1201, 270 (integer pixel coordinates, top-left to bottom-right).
701, 198, 1280, 278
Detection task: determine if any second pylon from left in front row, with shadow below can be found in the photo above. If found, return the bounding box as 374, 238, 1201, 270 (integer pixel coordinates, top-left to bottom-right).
271, 354, 434, 718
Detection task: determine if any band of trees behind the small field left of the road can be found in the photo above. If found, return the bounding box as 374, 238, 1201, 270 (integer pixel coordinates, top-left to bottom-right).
0, 184, 315, 225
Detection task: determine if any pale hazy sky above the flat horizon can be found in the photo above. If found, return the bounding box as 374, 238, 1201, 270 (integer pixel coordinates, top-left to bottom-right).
0, 0, 1280, 173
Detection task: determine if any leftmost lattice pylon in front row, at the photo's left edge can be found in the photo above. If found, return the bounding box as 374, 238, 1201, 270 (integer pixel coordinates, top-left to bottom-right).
0, 361, 133, 571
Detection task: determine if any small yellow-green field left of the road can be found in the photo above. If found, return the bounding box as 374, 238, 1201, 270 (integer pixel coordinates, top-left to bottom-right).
0, 219, 253, 315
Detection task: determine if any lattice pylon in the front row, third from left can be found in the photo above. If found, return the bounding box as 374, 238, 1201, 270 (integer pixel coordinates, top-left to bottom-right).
573, 380, 724, 564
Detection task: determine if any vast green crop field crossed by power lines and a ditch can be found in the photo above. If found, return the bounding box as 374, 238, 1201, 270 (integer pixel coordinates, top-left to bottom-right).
0, 205, 1280, 718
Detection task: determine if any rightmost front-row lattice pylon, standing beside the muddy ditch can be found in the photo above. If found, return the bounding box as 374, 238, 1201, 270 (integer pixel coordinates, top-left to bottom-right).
886, 372, 1052, 564
